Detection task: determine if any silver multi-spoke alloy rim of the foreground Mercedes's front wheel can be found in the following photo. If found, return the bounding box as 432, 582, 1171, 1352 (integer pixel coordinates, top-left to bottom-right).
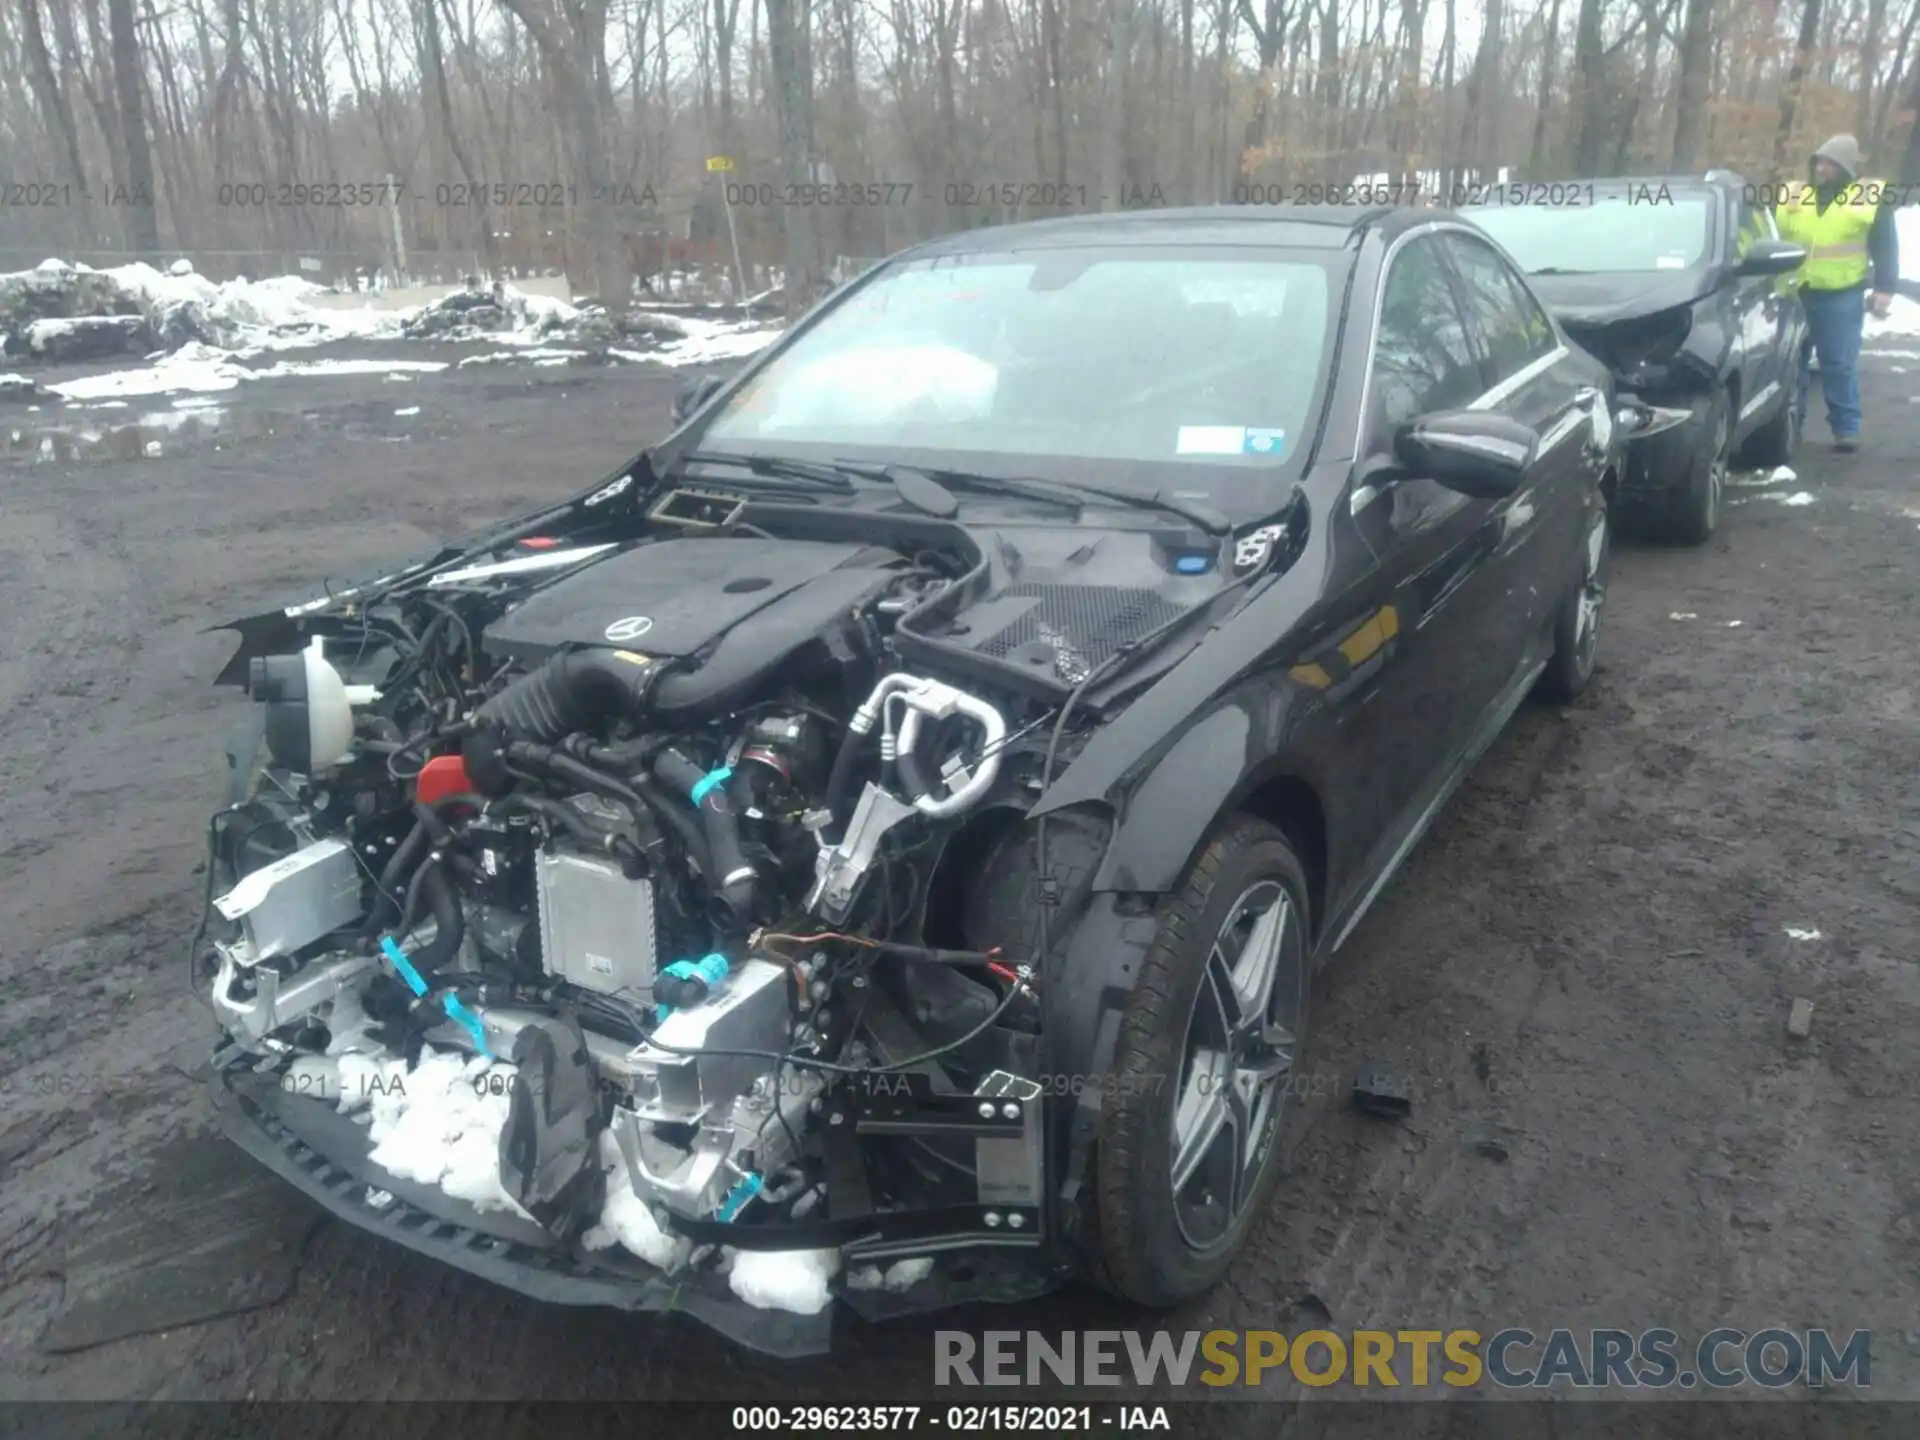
1171, 879, 1306, 1254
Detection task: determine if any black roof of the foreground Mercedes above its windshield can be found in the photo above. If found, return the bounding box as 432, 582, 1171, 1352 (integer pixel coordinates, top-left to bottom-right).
906, 205, 1446, 255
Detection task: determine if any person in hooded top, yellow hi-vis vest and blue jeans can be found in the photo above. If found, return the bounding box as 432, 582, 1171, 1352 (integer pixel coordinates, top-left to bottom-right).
1774, 134, 1901, 449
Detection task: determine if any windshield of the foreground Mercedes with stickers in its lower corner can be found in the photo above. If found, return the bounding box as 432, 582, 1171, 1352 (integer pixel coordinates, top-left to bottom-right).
695, 246, 1344, 501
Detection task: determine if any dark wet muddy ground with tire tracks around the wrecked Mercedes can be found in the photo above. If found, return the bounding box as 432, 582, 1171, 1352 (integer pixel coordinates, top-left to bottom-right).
0, 337, 1920, 1402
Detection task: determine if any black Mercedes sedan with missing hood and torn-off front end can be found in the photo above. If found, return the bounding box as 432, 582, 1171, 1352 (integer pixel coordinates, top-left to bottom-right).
192, 209, 1619, 1356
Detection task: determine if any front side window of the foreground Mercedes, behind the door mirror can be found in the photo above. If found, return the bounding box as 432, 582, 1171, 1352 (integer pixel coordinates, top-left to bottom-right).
1371, 236, 1486, 449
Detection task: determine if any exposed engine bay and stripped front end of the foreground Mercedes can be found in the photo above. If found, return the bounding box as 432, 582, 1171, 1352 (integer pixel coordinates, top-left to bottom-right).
194, 484, 1286, 1313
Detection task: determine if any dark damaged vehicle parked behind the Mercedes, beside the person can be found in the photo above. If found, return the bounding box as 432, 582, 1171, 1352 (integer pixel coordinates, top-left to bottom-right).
1463, 171, 1807, 545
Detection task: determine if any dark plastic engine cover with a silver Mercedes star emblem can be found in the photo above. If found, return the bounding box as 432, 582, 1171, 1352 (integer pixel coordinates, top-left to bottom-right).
482, 536, 897, 660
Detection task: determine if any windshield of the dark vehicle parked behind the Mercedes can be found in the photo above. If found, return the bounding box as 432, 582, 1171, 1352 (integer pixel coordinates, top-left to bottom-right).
1463, 196, 1707, 275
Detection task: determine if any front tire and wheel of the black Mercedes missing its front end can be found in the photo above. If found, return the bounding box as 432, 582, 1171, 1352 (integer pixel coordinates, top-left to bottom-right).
1089, 816, 1311, 1308
